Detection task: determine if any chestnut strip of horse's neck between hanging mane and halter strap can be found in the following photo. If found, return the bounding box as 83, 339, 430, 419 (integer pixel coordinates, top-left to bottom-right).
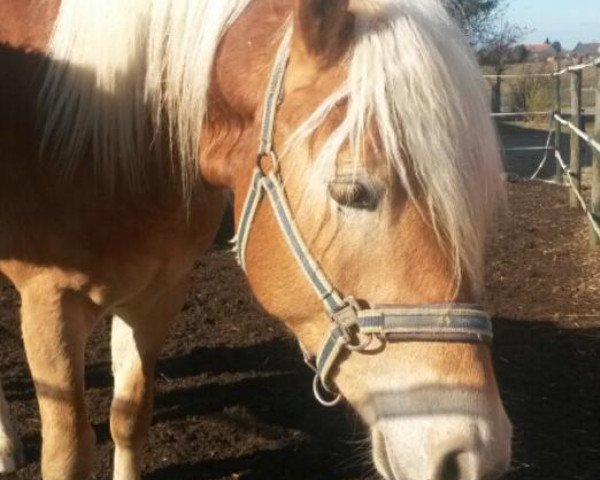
200, 0, 292, 187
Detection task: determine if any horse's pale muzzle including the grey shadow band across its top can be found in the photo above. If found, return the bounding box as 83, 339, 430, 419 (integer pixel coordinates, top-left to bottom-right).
365, 387, 512, 480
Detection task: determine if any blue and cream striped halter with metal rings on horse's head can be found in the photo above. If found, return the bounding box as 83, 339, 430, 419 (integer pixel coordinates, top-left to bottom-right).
236, 22, 493, 406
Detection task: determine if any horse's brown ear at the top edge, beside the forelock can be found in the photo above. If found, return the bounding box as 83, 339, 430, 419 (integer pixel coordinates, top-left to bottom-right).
295, 0, 354, 62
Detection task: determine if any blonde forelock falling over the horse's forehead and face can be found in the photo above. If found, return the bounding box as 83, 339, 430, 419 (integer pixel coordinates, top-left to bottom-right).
288, 0, 504, 293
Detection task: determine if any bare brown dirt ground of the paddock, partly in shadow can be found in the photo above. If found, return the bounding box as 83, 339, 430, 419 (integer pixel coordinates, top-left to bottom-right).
0, 183, 600, 480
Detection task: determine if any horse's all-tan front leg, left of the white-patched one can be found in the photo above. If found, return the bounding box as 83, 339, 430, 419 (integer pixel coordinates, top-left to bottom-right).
21, 279, 97, 480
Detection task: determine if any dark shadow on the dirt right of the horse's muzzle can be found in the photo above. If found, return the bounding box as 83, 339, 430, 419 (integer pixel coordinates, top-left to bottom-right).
495, 318, 600, 480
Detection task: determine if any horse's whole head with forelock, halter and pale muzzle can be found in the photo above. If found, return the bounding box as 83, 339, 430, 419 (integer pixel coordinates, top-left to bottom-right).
209, 0, 511, 480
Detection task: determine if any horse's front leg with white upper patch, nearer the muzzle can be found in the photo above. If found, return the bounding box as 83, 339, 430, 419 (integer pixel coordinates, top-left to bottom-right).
110, 279, 188, 480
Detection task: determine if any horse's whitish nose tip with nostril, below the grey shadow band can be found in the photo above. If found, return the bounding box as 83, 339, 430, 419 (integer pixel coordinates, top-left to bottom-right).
371, 414, 512, 480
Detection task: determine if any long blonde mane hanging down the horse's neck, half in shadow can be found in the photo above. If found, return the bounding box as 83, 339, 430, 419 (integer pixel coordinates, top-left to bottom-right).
41, 0, 250, 196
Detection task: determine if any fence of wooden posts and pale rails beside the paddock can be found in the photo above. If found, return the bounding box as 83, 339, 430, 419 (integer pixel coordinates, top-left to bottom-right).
484, 57, 600, 249
